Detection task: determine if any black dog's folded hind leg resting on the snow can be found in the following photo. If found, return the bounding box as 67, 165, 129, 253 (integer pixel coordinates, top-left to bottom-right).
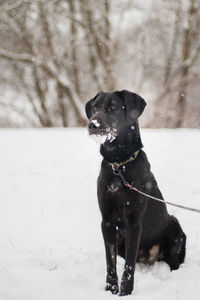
163, 216, 186, 270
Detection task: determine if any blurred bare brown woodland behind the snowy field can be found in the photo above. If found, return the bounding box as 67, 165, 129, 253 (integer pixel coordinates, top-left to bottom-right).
0, 0, 200, 128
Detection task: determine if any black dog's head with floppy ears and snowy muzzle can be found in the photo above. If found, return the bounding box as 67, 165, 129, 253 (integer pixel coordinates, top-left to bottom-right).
85, 90, 146, 143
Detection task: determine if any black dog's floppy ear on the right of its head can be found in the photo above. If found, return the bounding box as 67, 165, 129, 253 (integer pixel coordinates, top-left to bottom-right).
118, 90, 146, 119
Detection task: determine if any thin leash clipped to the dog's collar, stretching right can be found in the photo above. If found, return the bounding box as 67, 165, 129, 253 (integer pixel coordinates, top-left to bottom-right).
112, 167, 200, 213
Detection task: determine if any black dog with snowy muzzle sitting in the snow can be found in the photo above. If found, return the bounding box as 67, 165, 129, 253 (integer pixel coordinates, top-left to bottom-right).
86, 90, 186, 296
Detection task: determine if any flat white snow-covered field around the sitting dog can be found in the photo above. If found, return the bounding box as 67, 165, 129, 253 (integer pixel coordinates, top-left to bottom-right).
0, 129, 200, 300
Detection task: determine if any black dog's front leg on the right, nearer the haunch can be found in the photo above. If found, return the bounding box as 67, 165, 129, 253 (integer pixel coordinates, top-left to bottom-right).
120, 220, 142, 296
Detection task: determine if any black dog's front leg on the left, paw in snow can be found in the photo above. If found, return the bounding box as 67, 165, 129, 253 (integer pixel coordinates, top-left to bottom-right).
101, 220, 119, 294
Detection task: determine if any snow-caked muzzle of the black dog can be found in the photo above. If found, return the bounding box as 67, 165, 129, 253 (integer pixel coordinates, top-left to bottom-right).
88, 120, 117, 144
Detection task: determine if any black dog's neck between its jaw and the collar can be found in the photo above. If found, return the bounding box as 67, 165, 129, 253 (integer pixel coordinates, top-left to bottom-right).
100, 128, 143, 163
